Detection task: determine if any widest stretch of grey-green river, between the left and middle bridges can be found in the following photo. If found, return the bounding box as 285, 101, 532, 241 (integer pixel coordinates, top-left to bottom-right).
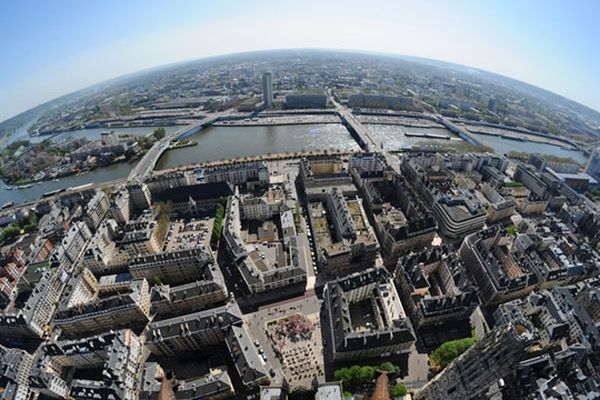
156, 124, 360, 169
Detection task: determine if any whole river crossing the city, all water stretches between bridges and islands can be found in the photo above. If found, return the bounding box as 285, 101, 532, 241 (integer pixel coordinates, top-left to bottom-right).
0, 124, 586, 205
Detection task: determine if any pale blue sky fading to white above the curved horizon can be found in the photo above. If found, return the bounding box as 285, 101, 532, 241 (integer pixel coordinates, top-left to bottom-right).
0, 0, 600, 121
